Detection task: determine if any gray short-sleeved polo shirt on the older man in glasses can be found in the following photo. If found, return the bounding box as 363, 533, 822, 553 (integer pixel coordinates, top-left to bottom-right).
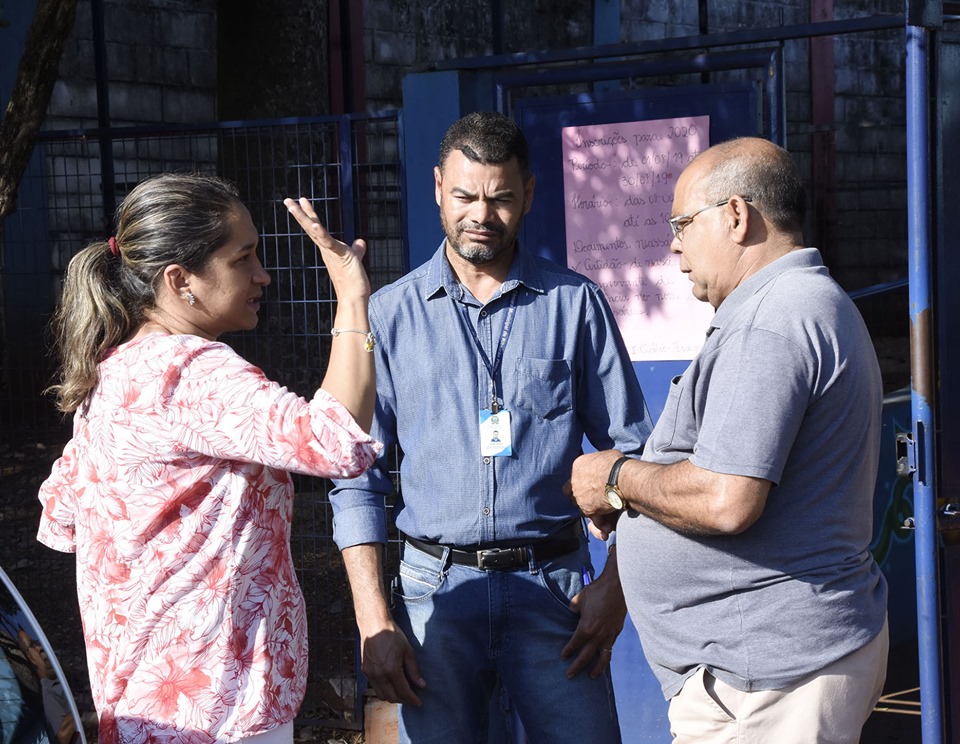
617, 248, 887, 698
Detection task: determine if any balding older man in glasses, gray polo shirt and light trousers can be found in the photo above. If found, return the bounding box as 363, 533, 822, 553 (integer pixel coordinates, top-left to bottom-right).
571, 138, 887, 743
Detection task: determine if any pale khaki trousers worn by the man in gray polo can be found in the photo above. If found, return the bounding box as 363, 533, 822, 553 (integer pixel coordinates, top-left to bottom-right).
668, 623, 889, 744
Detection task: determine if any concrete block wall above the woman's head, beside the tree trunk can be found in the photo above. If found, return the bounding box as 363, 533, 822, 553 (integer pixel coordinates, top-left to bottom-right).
25, 0, 217, 346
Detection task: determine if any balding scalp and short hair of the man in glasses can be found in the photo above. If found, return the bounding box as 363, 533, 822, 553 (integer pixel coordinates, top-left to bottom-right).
688, 137, 806, 235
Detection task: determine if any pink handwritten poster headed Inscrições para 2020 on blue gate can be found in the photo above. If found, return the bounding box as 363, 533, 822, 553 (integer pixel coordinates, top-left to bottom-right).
562, 116, 713, 361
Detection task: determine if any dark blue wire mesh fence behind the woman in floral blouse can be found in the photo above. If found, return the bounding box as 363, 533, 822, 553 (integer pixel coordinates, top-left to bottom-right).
0, 114, 404, 728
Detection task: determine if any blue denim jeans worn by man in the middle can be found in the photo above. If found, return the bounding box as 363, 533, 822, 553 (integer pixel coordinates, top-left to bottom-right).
394, 543, 620, 744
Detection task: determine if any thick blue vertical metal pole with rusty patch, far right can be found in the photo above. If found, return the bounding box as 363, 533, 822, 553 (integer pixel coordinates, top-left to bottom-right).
907, 25, 943, 744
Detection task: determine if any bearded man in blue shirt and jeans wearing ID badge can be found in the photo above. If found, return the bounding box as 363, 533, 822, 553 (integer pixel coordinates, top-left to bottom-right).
332, 113, 652, 744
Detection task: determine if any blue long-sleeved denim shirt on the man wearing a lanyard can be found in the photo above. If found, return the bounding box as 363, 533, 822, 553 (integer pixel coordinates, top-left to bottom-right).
331, 243, 652, 548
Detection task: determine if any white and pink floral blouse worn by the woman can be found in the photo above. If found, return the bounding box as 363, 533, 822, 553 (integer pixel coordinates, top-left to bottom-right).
39, 335, 381, 744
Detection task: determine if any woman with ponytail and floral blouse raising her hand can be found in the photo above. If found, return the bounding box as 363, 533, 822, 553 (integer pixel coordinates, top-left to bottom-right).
39, 174, 381, 744
